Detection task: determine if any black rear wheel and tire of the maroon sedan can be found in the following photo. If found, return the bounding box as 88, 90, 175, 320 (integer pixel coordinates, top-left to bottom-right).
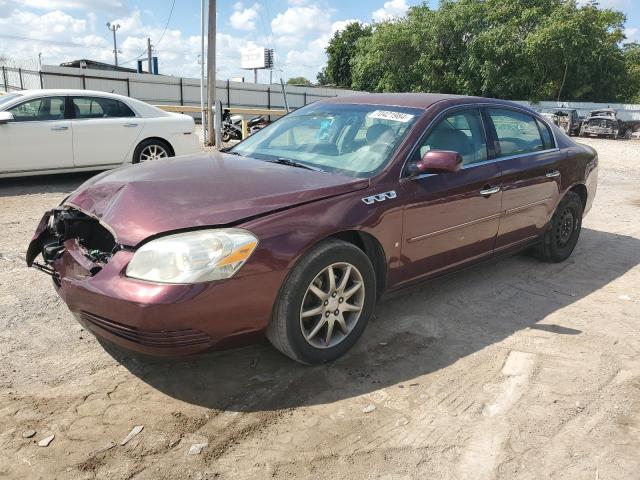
534, 192, 584, 263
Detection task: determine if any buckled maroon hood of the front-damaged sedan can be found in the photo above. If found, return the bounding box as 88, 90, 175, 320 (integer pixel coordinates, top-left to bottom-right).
64, 152, 369, 246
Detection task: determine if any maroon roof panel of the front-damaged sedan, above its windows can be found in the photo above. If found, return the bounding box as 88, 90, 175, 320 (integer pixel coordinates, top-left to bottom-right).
321, 93, 531, 110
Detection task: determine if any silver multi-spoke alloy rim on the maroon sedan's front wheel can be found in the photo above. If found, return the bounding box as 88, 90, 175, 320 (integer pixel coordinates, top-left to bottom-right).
300, 262, 365, 348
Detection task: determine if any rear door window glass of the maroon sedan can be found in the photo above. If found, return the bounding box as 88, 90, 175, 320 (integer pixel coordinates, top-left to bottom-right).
489, 108, 548, 157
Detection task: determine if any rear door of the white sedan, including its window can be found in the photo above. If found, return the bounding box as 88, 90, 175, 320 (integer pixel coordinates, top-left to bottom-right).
71, 96, 144, 167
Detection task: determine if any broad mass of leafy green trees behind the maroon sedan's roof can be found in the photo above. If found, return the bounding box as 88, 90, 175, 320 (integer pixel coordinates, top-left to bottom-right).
352, 0, 629, 101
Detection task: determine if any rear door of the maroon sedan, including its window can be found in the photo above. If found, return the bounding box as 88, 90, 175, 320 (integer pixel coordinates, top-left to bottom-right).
485, 107, 562, 251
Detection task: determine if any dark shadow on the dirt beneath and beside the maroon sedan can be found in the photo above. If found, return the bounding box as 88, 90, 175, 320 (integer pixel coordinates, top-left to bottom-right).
102, 229, 640, 412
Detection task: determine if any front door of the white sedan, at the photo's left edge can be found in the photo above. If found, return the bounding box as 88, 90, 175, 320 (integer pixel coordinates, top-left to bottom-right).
0, 96, 73, 173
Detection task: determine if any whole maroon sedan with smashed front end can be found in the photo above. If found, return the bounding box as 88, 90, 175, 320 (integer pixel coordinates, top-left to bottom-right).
27, 94, 598, 363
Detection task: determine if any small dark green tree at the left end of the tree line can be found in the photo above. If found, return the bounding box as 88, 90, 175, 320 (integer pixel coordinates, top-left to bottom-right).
323, 22, 372, 87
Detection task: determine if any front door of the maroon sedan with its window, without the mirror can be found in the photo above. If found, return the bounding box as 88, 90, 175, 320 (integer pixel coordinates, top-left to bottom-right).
398, 109, 502, 283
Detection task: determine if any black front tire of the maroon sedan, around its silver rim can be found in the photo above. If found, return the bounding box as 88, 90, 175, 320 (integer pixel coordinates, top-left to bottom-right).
266, 239, 376, 365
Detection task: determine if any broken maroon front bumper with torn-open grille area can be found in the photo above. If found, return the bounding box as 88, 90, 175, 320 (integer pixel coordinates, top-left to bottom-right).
27, 207, 285, 356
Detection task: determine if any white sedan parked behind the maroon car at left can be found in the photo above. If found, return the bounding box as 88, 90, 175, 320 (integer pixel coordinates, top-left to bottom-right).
0, 90, 199, 178
